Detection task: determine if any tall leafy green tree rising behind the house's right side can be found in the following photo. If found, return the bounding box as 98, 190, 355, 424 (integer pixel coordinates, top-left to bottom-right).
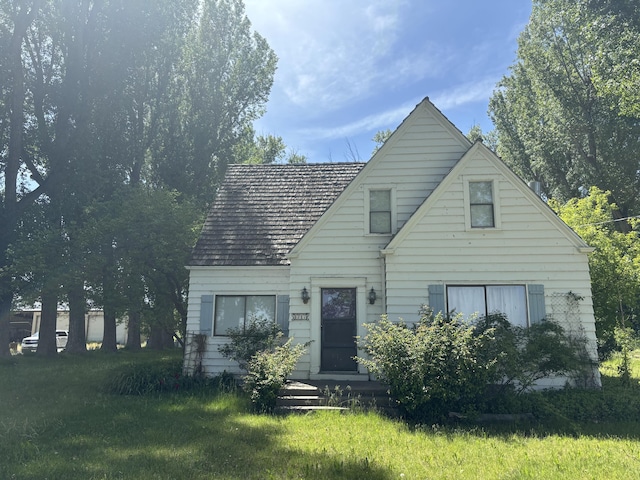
489, 0, 640, 220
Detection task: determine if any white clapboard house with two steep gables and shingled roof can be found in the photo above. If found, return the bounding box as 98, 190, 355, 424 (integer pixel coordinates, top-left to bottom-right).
185, 99, 600, 387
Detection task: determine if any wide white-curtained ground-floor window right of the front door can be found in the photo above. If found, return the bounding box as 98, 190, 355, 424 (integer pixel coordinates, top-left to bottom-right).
447, 285, 528, 327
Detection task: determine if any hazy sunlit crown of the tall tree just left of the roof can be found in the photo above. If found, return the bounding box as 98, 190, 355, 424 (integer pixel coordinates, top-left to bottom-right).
152, 0, 277, 206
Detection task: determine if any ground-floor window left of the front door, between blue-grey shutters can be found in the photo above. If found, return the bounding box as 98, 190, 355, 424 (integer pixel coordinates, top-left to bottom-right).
215, 295, 276, 335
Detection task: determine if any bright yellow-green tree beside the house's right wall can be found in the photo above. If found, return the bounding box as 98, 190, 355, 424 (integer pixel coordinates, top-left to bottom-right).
550, 187, 640, 355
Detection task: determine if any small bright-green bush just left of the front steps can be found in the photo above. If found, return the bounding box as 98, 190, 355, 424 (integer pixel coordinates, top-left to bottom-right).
244, 339, 306, 412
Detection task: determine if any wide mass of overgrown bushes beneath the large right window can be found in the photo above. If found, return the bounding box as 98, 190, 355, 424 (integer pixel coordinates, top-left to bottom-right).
358, 311, 591, 421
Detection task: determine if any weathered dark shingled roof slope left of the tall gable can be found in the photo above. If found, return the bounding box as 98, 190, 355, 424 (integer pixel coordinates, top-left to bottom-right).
189, 163, 365, 266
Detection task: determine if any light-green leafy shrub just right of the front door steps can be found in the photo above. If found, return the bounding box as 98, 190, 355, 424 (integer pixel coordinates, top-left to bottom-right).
358, 314, 497, 418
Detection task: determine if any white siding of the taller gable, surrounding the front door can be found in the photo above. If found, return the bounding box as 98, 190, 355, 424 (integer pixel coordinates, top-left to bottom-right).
290, 105, 470, 376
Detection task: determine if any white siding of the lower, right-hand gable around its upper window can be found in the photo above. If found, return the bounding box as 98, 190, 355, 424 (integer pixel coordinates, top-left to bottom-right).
386, 155, 597, 386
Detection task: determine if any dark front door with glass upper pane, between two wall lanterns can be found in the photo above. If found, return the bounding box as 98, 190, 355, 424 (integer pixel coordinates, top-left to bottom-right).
320, 288, 358, 372
